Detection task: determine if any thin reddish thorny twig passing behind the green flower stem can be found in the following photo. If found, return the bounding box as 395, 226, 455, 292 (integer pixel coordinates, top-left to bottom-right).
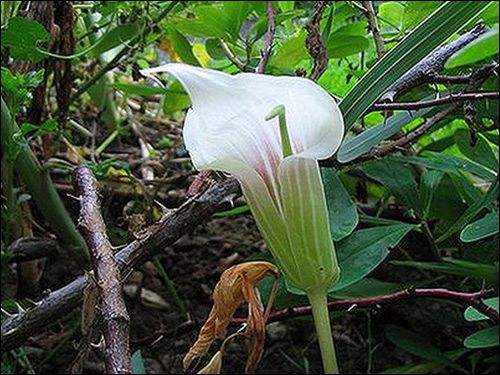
231, 288, 498, 325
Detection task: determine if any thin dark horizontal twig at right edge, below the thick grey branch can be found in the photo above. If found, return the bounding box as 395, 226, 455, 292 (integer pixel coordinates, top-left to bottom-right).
371, 91, 500, 111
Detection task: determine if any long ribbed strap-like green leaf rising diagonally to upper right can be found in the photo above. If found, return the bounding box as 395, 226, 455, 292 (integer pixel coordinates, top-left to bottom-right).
340, 1, 490, 129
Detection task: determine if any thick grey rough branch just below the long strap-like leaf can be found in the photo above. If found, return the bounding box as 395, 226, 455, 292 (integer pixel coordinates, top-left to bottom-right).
380, 24, 487, 102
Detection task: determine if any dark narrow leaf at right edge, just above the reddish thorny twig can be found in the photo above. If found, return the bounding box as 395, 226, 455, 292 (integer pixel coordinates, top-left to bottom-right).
391, 258, 498, 284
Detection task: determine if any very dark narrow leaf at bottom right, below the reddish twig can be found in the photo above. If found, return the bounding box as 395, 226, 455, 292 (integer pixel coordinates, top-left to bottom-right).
385, 324, 461, 369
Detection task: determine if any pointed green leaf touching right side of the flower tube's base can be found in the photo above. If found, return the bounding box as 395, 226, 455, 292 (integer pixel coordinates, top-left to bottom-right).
330, 224, 414, 292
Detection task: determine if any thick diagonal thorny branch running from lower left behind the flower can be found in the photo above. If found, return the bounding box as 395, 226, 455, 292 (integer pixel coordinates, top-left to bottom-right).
1, 178, 239, 351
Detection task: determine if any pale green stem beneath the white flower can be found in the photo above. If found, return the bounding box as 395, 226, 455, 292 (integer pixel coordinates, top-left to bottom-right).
307, 290, 339, 374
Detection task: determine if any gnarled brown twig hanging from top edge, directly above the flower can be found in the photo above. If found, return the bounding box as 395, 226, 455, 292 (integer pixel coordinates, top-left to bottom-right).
306, 1, 328, 81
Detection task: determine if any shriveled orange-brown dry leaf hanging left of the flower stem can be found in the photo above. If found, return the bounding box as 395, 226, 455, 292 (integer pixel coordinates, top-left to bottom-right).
183, 262, 278, 369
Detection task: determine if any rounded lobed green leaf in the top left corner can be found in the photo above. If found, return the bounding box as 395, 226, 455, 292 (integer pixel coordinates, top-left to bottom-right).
1, 17, 50, 63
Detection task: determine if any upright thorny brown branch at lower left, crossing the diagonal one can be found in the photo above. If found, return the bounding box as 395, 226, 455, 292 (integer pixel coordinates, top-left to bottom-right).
74, 166, 132, 374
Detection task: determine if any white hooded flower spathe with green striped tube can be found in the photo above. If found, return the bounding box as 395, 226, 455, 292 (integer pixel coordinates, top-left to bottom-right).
143, 63, 344, 292
